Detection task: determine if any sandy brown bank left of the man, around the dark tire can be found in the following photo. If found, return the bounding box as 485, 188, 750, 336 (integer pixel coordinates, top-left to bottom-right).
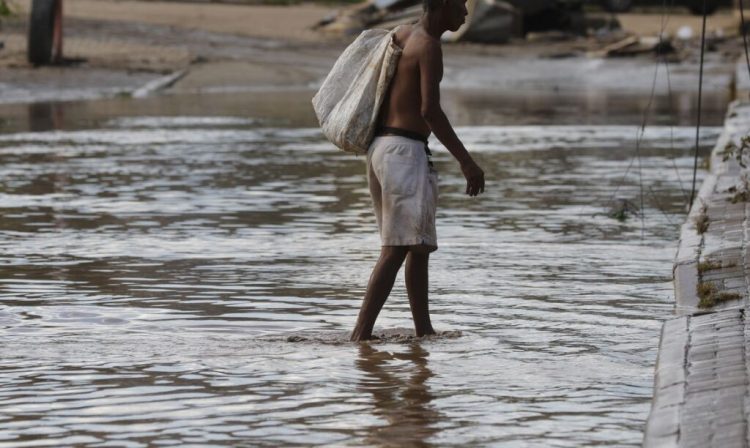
0, 0, 343, 103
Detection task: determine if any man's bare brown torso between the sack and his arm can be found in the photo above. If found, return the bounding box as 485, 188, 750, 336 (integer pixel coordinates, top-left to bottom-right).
380, 25, 442, 137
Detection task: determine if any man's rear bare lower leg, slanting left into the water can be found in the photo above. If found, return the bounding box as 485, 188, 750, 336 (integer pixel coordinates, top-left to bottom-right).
350, 246, 409, 341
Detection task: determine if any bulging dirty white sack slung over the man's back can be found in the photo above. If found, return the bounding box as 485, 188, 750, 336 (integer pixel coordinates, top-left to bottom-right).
312, 28, 401, 154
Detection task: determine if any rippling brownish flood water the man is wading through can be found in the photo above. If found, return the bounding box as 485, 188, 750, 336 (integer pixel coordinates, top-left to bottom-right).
0, 90, 720, 447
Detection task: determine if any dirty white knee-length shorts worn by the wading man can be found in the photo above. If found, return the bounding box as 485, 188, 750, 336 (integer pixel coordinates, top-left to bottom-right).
367, 135, 438, 252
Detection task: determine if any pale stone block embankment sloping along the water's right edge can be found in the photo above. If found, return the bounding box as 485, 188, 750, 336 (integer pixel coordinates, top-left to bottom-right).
643, 102, 750, 448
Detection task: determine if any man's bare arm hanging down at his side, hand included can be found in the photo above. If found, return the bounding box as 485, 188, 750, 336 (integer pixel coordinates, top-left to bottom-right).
419, 42, 484, 196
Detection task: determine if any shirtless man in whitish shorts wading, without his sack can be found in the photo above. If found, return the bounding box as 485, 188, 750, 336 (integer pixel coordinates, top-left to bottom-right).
351, 0, 484, 341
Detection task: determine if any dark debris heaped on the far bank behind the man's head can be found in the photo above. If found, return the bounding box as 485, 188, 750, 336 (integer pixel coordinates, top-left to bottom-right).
313, 0, 736, 61
